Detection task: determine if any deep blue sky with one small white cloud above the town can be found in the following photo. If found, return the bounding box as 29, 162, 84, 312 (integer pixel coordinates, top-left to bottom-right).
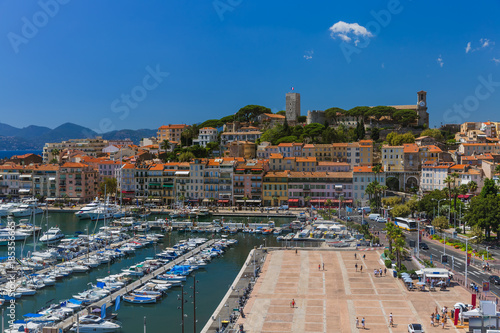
0, 0, 500, 135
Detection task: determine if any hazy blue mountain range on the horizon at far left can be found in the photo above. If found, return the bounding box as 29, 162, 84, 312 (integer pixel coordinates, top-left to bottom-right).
0, 123, 156, 150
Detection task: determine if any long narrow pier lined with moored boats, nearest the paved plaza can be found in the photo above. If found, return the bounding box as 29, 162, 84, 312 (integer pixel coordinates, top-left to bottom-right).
47, 239, 216, 333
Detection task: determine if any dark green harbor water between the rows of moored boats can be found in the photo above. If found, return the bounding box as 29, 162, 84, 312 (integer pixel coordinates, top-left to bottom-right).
0, 212, 291, 333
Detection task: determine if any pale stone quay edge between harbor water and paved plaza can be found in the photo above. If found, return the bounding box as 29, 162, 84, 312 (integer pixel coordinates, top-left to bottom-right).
201, 248, 267, 333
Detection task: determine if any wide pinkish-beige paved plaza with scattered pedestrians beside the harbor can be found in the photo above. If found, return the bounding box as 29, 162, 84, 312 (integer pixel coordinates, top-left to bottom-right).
238, 249, 471, 333
